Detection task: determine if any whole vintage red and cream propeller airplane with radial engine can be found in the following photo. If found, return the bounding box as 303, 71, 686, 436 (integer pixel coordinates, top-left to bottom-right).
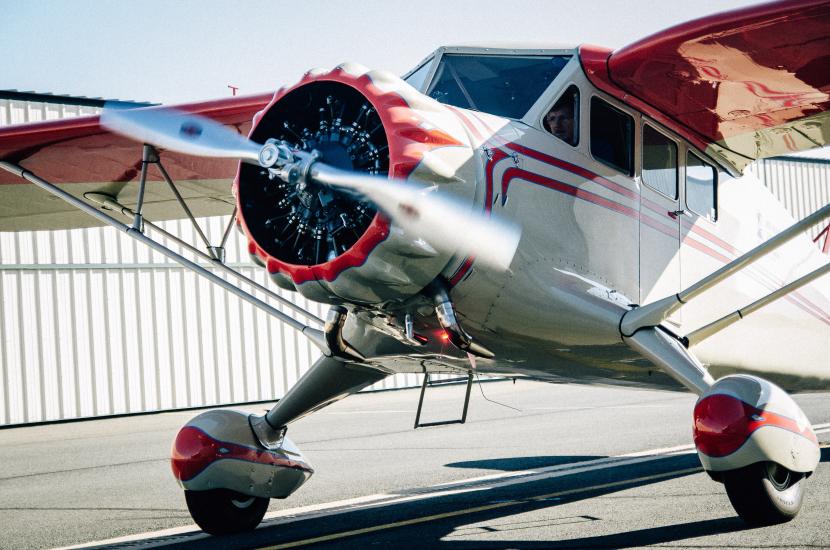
0, 0, 830, 533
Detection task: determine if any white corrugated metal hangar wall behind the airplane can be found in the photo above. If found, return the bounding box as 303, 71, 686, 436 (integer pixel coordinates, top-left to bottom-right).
0, 91, 830, 425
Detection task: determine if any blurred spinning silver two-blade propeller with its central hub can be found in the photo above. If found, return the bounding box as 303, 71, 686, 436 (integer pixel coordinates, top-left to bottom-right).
101, 108, 521, 270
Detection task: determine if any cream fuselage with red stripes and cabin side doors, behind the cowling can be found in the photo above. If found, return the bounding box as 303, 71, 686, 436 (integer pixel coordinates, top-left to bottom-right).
406, 48, 830, 392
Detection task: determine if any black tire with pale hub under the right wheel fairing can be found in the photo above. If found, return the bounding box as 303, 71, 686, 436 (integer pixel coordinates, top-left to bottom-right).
723, 462, 805, 525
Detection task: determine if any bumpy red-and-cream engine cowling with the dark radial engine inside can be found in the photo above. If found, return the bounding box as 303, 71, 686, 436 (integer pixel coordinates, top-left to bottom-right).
234, 64, 483, 304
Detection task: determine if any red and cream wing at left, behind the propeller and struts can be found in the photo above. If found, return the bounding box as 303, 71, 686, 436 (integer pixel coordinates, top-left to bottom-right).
0, 94, 272, 231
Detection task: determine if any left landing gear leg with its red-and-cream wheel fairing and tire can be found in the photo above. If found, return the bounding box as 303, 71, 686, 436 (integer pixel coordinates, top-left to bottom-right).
171, 308, 388, 535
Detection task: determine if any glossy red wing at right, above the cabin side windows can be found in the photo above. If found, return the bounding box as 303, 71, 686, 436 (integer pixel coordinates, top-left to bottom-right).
580, 0, 830, 171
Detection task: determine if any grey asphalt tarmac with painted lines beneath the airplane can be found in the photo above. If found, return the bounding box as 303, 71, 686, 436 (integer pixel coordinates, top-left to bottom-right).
0, 381, 830, 549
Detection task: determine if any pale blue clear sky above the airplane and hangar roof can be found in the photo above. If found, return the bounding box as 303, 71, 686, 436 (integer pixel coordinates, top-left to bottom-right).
0, 0, 768, 103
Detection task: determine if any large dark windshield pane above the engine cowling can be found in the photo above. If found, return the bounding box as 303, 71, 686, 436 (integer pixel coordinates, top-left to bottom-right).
426, 54, 570, 118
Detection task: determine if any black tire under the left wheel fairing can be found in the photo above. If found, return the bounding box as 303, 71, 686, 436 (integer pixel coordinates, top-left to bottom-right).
184, 489, 269, 535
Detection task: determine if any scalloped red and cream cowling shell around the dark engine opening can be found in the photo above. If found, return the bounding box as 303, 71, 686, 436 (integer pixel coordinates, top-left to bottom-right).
234, 63, 475, 303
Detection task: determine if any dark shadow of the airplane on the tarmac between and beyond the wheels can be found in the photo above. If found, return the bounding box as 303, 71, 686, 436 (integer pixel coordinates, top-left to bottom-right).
94, 448, 830, 550
